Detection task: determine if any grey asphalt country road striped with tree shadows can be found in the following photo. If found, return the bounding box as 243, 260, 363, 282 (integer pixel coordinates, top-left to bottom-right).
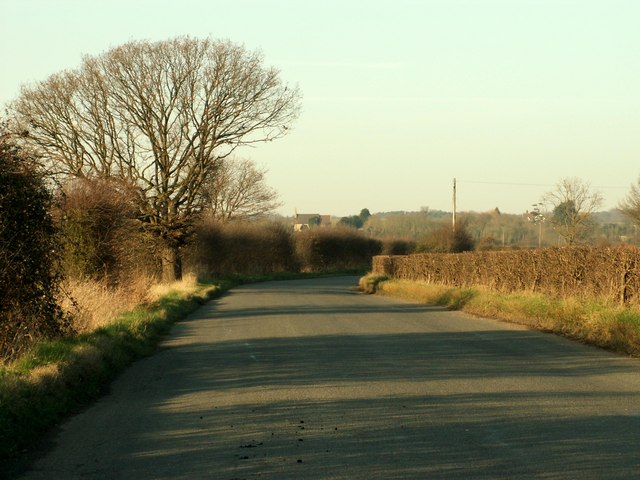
16, 277, 640, 480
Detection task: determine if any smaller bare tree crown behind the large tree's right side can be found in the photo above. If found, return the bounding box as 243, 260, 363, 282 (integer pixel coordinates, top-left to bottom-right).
205, 157, 281, 222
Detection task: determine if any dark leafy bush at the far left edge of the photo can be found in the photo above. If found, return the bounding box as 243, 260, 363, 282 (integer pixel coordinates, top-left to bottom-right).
0, 141, 70, 361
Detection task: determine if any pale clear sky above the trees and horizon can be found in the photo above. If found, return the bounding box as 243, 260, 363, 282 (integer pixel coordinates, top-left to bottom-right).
0, 0, 640, 216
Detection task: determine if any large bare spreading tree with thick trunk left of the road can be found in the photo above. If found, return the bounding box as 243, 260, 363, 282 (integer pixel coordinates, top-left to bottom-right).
10, 37, 300, 280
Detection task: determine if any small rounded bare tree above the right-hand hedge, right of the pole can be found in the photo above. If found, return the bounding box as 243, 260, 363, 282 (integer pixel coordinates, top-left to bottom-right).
542, 177, 603, 245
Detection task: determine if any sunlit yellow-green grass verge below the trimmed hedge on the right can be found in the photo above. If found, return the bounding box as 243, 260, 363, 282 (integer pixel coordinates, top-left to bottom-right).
360, 275, 640, 357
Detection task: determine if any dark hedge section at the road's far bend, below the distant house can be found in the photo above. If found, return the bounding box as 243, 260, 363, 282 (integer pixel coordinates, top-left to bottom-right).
294, 227, 382, 272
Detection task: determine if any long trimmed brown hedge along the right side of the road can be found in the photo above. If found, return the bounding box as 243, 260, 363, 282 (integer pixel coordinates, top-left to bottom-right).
372, 245, 640, 305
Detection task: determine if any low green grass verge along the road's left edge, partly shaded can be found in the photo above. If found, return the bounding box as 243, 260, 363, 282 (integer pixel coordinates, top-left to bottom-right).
0, 281, 233, 458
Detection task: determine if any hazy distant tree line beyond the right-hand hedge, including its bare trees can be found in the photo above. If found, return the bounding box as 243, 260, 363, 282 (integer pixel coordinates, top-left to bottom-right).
363, 178, 640, 251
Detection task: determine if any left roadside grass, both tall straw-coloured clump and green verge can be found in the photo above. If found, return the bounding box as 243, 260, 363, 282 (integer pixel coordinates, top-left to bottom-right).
0, 277, 223, 460
